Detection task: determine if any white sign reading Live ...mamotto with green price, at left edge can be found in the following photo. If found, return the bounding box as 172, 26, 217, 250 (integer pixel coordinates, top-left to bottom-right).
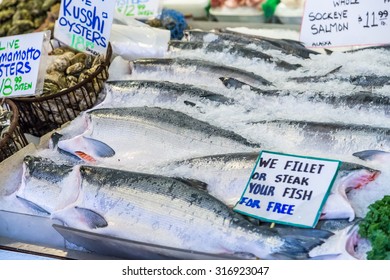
0, 32, 50, 97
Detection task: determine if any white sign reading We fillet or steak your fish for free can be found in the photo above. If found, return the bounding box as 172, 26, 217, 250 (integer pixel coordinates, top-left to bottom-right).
234, 151, 341, 227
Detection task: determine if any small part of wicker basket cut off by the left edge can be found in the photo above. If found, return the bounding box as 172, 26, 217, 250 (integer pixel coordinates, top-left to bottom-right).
0, 99, 28, 162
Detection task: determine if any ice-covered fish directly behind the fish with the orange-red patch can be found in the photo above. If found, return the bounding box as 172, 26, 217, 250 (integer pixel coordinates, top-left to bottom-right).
105, 80, 234, 106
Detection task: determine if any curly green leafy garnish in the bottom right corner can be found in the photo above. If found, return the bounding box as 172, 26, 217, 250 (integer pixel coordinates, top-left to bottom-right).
359, 195, 390, 260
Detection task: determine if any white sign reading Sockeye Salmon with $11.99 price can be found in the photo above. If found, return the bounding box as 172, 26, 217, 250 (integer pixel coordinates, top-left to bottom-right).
300, 0, 390, 47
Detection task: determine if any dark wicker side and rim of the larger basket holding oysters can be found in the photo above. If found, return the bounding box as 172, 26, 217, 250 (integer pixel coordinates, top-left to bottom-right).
12, 44, 112, 137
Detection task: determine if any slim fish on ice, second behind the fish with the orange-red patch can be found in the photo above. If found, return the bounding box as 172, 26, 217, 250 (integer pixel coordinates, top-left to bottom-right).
130, 58, 272, 87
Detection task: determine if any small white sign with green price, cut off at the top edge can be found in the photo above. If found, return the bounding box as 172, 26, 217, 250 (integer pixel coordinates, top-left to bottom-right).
115, 0, 160, 19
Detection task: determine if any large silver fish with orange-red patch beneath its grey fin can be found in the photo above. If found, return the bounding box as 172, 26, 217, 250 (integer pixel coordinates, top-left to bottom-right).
58, 107, 260, 168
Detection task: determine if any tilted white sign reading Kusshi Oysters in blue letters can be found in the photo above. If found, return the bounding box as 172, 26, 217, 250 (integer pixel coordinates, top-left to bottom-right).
54, 0, 115, 55
